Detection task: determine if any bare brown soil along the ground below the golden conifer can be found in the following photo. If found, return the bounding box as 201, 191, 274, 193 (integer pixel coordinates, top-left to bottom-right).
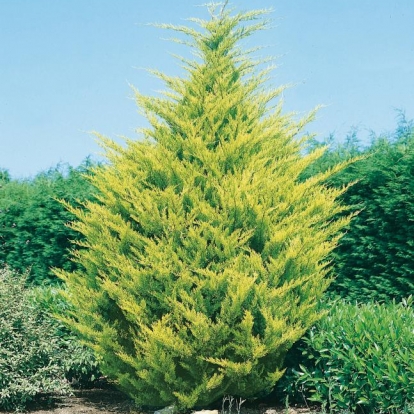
0, 388, 316, 414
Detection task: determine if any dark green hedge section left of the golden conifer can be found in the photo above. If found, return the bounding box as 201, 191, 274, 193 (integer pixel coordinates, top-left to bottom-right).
0, 160, 95, 284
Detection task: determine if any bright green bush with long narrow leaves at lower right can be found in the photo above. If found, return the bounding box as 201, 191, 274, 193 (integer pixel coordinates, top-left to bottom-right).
282, 297, 414, 413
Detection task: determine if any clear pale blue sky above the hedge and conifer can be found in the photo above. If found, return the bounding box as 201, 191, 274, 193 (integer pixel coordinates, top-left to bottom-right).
0, 0, 414, 178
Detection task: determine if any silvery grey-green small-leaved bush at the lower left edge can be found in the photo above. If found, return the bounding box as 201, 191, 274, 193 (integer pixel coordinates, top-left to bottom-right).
0, 268, 69, 409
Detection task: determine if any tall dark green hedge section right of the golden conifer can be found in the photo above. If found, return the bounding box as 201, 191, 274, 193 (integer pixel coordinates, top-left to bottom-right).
304, 114, 414, 302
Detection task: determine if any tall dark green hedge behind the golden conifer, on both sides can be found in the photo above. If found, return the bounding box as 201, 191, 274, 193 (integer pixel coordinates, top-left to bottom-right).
0, 113, 414, 301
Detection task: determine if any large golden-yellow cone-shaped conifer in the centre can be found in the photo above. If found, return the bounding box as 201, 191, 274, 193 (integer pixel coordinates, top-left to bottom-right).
57, 6, 348, 408
